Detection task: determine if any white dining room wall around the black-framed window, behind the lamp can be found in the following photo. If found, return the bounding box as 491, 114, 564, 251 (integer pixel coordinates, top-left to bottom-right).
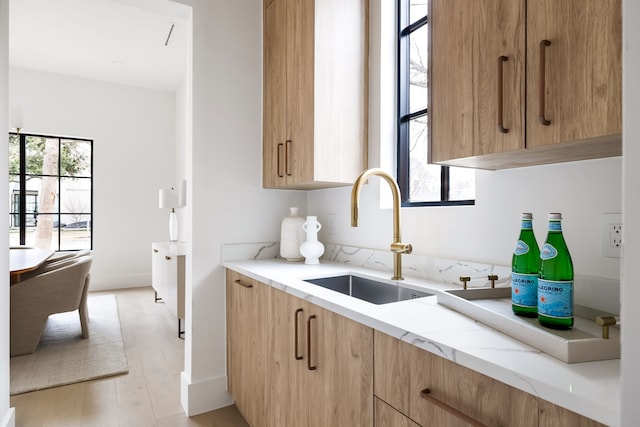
9, 68, 176, 290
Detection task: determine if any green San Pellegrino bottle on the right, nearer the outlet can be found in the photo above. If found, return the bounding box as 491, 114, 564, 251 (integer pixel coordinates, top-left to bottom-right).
538, 213, 573, 329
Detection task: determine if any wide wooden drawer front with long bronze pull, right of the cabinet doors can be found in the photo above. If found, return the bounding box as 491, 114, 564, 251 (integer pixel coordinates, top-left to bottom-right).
375, 332, 538, 427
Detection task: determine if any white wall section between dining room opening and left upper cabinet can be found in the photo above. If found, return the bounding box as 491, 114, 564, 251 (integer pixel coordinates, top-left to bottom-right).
174, 0, 306, 415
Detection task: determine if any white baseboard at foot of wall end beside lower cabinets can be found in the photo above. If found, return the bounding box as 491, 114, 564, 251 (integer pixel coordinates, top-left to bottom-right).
180, 371, 233, 417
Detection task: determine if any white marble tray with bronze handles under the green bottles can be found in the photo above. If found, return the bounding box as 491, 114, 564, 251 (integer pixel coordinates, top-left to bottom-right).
438, 287, 620, 363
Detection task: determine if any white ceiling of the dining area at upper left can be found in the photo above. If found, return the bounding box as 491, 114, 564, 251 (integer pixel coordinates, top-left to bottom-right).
9, 0, 190, 91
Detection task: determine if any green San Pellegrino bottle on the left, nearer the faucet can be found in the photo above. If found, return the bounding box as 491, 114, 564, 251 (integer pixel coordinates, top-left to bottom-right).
511, 213, 540, 317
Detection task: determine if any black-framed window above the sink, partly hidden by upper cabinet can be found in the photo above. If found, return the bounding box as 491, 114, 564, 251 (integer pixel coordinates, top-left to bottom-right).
397, 0, 475, 206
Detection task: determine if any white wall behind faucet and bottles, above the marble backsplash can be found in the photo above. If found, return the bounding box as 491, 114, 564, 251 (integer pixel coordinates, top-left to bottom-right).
308, 158, 621, 280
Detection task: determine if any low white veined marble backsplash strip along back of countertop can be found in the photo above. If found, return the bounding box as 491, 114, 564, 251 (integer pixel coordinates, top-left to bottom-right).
222, 242, 620, 314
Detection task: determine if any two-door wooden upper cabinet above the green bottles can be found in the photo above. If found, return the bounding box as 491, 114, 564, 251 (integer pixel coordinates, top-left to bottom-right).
430, 0, 622, 169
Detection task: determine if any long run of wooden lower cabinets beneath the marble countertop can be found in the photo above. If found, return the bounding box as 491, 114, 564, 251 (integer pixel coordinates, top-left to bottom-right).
226, 270, 602, 427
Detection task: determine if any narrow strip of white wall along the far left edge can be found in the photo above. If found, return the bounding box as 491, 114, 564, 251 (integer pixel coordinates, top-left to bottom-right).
0, 0, 15, 427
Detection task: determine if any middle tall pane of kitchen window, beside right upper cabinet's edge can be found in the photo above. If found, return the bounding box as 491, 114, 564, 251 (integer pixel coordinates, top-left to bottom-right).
409, 25, 429, 113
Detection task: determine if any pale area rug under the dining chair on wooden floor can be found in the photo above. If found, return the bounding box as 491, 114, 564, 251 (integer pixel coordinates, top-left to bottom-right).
10, 295, 129, 395
